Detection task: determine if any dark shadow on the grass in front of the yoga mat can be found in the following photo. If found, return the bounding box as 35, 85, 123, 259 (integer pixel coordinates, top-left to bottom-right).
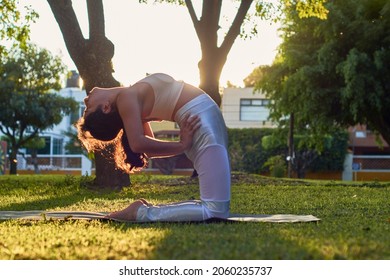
103, 222, 329, 260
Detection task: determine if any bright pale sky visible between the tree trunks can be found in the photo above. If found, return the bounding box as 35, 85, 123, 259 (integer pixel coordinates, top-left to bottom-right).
20, 0, 280, 86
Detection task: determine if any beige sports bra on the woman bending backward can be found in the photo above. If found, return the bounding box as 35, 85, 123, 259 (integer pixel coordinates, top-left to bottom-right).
137, 73, 184, 120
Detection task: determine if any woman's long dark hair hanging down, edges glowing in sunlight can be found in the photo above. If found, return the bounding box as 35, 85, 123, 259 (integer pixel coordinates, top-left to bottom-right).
76, 106, 147, 173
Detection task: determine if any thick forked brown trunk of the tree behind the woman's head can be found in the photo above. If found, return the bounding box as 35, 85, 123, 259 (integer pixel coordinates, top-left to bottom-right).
48, 0, 130, 189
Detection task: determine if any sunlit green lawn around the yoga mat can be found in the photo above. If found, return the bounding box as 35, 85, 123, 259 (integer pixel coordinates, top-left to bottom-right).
0, 174, 390, 260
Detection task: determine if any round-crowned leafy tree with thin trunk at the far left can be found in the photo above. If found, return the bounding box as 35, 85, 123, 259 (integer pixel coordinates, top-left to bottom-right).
0, 45, 77, 174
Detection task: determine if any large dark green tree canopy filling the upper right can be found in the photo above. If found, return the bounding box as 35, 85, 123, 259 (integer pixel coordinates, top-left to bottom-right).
256, 0, 390, 147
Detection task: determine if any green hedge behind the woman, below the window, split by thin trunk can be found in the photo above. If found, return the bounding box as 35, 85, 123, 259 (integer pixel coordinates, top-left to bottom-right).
228, 128, 348, 178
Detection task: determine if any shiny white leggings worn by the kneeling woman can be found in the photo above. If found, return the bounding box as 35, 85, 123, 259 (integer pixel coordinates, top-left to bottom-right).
137, 94, 231, 221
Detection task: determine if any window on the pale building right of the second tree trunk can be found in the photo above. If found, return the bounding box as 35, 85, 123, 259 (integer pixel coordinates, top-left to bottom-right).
240, 99, 269, 121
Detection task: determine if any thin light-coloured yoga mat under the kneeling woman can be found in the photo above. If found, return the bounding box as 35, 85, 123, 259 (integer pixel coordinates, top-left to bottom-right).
0, 210, 320, 223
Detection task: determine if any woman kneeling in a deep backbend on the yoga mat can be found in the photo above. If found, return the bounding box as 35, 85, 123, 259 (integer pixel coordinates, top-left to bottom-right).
77, 73, 230, 221
